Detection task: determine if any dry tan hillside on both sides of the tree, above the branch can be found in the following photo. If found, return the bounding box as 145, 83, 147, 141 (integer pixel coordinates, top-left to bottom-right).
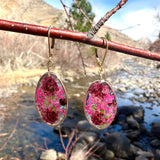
0, 0, 148, 49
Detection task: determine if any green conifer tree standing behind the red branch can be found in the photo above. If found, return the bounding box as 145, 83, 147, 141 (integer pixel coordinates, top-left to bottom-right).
69, 0, 95, 32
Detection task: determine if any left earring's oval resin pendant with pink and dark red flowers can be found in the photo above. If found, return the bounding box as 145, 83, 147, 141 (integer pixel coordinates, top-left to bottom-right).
35, 72, 68, 127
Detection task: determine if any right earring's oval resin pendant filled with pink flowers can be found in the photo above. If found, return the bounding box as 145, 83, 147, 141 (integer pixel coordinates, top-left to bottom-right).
84, 81, 117, 129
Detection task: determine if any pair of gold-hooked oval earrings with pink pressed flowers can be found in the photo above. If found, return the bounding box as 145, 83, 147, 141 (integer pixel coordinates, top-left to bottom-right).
35, 27, 117, 129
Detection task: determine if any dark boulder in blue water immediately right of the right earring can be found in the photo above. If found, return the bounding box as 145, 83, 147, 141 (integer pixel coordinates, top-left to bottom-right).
118, 106, 144, 123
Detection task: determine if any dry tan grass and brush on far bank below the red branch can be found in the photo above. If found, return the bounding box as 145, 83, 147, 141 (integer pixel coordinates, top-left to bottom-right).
0, 31, 124, 88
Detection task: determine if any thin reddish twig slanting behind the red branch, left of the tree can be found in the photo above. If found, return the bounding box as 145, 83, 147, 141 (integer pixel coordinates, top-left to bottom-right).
60, 0, 86, 76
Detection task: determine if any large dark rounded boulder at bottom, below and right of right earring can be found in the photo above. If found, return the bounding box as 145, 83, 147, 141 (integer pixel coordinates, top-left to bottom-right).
106, 132, 131, 158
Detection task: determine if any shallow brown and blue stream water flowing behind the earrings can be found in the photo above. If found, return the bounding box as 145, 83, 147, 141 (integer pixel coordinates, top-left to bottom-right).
0, 57, 160, 160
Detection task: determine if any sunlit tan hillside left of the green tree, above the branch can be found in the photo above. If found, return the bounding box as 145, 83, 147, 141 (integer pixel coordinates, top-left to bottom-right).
0, 0, 62, 25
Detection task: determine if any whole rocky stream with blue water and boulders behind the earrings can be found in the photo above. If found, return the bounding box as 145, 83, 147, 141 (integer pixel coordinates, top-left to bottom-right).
0, 58, 160, 160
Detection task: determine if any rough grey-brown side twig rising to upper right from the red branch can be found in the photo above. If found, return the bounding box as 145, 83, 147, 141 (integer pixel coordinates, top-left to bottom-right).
87, 0, 128, 39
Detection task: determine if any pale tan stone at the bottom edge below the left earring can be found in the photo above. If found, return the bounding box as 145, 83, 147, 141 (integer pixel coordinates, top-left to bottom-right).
40, 149, 57, 160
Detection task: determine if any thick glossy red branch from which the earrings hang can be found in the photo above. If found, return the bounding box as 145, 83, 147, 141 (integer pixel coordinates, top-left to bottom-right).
0, 19, 160, 61
